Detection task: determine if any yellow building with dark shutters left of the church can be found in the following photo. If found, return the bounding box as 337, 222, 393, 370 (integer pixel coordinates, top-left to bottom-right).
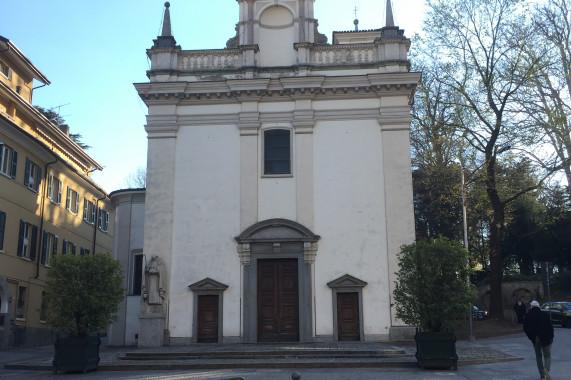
0, 36, 115, 349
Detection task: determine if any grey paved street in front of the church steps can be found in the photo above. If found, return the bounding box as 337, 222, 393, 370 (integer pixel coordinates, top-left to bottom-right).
0, 327, 571, 380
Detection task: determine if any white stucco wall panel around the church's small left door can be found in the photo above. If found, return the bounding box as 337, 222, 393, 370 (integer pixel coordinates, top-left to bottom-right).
169, 125, 240, 337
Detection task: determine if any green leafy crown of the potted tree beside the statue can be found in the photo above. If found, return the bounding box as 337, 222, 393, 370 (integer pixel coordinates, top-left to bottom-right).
46, 254, 124, 337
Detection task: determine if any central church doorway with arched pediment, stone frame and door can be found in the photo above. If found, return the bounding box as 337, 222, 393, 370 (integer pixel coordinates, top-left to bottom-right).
236, 219, 319, 342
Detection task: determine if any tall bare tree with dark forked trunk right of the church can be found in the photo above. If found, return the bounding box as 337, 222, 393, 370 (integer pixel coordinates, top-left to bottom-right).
423, 0, 556, 318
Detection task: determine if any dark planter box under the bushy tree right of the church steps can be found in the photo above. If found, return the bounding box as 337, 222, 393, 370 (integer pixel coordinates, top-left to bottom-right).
414, 331, 458, 370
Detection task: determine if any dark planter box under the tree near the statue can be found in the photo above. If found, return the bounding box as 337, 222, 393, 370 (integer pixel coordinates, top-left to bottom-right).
52, 335, 101, 374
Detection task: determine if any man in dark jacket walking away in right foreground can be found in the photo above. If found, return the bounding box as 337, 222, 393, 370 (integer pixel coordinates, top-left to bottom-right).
523, 301, 553, 380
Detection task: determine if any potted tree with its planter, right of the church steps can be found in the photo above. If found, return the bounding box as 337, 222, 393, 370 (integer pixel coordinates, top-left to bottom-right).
394, 237, 476, 369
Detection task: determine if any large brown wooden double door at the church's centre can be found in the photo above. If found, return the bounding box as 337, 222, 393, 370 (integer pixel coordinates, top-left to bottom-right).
257, 259, 299, 342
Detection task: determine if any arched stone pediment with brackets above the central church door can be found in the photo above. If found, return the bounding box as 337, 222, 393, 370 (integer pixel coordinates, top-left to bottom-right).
235, 218, 320, 265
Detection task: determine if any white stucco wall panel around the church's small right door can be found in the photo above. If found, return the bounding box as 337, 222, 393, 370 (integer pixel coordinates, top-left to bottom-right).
314, 120, 390, 335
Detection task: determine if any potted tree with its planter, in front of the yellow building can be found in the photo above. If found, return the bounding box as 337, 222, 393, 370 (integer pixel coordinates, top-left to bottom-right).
46, 254, 124, 373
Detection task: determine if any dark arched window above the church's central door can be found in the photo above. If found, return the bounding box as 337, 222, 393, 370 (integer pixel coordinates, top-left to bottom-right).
264, 129, 291, 175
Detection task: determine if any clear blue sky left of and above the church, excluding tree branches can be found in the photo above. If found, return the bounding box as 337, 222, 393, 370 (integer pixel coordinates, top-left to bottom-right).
0, 0, 425, 192
